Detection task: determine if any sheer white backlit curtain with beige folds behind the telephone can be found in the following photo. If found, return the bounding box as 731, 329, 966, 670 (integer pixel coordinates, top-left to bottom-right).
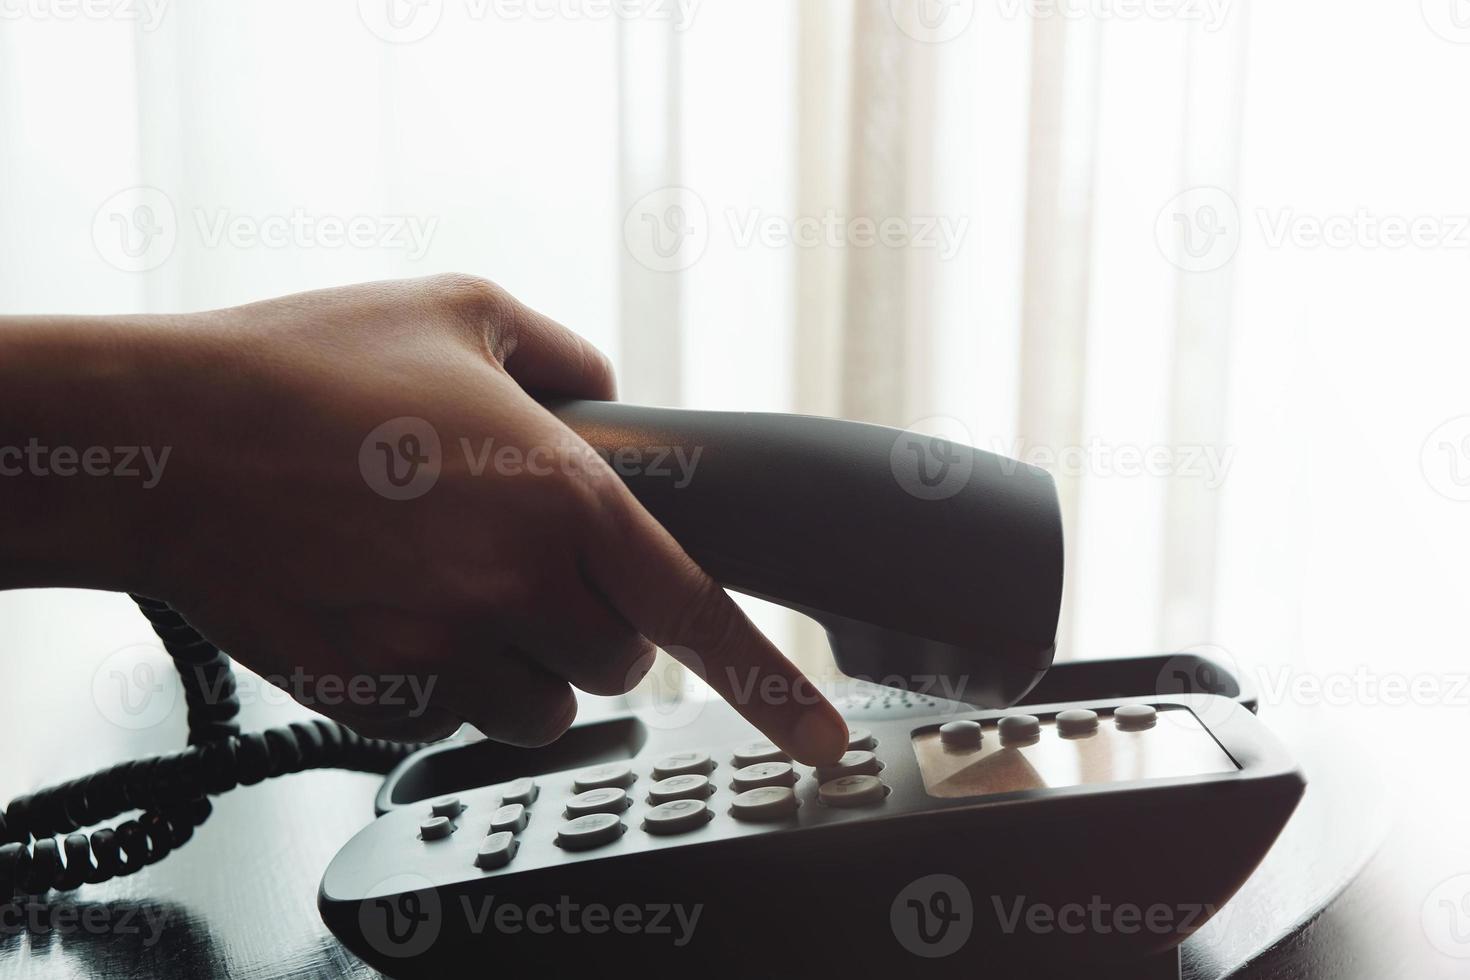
0, 0, 1470, 714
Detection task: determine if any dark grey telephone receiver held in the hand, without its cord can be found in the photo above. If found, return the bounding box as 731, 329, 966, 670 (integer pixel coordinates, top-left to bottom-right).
550, 401, 1063, 708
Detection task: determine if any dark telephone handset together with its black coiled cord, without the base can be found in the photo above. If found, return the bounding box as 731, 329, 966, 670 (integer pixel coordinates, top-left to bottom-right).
0, 401, 1061, 895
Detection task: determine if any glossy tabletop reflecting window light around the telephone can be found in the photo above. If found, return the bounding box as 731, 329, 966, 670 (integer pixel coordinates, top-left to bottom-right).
0, 592, 1470, 980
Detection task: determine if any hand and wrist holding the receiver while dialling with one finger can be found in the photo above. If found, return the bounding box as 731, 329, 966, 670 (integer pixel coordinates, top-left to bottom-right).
0, 276, 845, 763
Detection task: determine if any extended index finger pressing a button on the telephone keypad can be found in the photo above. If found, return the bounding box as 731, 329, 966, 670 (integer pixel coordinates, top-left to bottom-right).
584, 478, 847, 765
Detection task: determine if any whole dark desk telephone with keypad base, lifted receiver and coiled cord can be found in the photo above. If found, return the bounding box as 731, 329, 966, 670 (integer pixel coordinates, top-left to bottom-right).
0, 403, 1304, 976
